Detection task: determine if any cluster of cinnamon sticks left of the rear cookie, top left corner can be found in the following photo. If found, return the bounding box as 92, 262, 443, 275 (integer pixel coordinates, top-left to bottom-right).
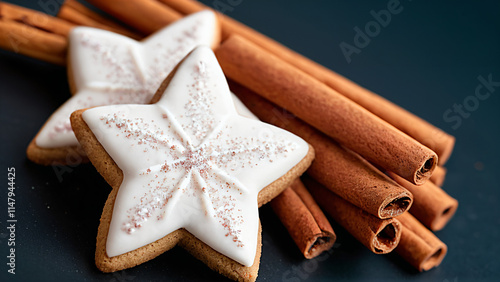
0, 0, 143, 65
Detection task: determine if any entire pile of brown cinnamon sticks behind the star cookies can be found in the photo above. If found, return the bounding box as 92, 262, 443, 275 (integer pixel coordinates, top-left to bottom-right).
0, 0, 458, 271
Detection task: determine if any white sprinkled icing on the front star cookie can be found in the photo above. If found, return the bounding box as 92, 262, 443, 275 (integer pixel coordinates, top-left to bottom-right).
83, 47, 309, 266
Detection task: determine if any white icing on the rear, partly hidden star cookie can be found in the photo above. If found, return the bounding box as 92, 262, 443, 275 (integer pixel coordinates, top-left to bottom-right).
36, 11, 218, 148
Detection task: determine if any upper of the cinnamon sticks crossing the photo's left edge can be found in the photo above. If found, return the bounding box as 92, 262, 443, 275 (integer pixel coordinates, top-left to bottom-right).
0, 2, 74, 37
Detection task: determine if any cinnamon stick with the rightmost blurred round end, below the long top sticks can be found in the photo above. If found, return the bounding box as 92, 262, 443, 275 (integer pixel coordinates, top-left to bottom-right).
388, 172, 458, 231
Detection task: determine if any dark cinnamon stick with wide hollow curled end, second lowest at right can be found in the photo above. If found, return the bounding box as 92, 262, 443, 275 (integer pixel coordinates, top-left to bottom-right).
303, 177, 401, 254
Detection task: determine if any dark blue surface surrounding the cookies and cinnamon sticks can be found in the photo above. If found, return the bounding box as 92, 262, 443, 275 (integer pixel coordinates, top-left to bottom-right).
0, 0, 500, 282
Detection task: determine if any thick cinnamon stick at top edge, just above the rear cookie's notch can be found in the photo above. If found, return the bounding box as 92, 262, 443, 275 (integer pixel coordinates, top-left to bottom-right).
87, 0, 182, 35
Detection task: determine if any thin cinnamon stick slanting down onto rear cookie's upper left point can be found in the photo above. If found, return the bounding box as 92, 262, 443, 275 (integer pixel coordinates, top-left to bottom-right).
57, 0, 143, 40
